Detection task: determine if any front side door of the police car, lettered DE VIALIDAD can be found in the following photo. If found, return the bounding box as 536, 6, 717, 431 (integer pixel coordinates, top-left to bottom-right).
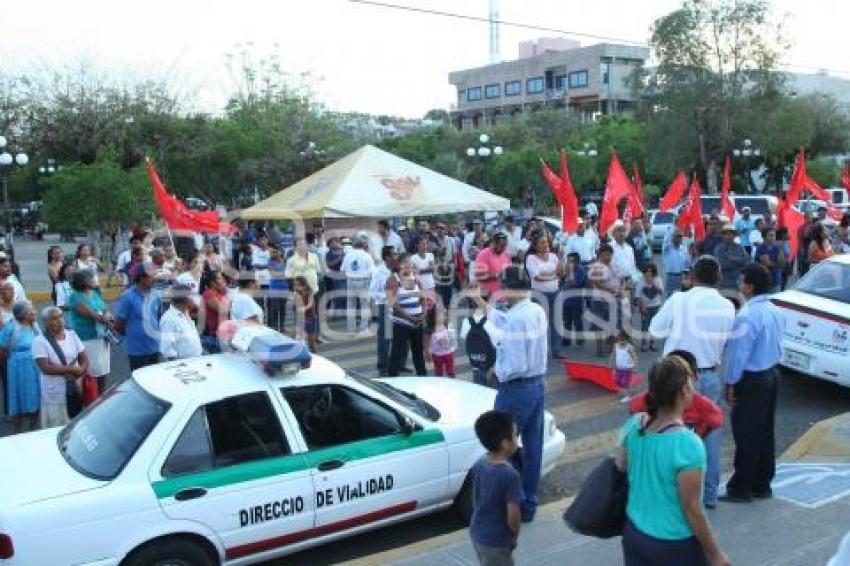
281, 385, 448, 535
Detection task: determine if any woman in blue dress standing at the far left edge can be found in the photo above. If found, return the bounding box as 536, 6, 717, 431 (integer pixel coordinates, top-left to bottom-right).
0, 301, 41, 433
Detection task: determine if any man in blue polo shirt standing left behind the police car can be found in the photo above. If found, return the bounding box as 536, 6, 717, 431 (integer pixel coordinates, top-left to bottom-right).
114, 263, 162, 371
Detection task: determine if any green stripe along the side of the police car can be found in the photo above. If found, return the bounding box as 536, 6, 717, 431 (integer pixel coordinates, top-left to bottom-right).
152, 429, 445, 499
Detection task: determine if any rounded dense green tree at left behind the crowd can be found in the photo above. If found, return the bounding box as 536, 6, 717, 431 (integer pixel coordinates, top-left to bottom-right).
44, 152, 154, 234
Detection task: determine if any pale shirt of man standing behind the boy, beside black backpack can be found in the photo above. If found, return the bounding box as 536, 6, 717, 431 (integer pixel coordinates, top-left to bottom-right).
487, 298, 549, 383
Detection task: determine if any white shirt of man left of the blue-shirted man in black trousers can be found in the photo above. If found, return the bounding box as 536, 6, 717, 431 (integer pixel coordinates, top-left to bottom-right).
649, 285, 735, 369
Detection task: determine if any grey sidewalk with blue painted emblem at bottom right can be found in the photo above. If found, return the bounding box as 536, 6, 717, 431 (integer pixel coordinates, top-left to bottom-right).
352, 413, 850, 566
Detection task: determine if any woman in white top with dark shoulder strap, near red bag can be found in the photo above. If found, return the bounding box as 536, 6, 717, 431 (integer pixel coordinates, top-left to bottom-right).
32, 307, 88, 428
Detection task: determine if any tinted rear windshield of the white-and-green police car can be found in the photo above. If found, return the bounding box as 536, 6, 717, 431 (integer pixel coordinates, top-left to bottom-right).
59, 379, 170, 480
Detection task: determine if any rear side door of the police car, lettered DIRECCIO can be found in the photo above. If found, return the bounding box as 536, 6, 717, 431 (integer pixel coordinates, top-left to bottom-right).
151, 391, 315, 560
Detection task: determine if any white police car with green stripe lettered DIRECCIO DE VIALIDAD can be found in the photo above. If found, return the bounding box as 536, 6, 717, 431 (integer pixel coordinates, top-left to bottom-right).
0, 327, 565, 566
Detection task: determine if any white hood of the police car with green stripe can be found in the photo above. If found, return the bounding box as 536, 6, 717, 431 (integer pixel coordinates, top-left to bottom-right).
380, 377, 496, 426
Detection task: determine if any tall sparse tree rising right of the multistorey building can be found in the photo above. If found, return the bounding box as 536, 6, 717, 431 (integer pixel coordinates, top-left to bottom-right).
643, 0, 787, 189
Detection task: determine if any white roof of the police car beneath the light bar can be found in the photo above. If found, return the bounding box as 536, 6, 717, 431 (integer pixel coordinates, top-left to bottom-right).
133, 353, 348, 405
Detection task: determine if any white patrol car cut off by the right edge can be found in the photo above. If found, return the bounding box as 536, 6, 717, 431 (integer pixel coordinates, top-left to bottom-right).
773, 254, 850, 387
